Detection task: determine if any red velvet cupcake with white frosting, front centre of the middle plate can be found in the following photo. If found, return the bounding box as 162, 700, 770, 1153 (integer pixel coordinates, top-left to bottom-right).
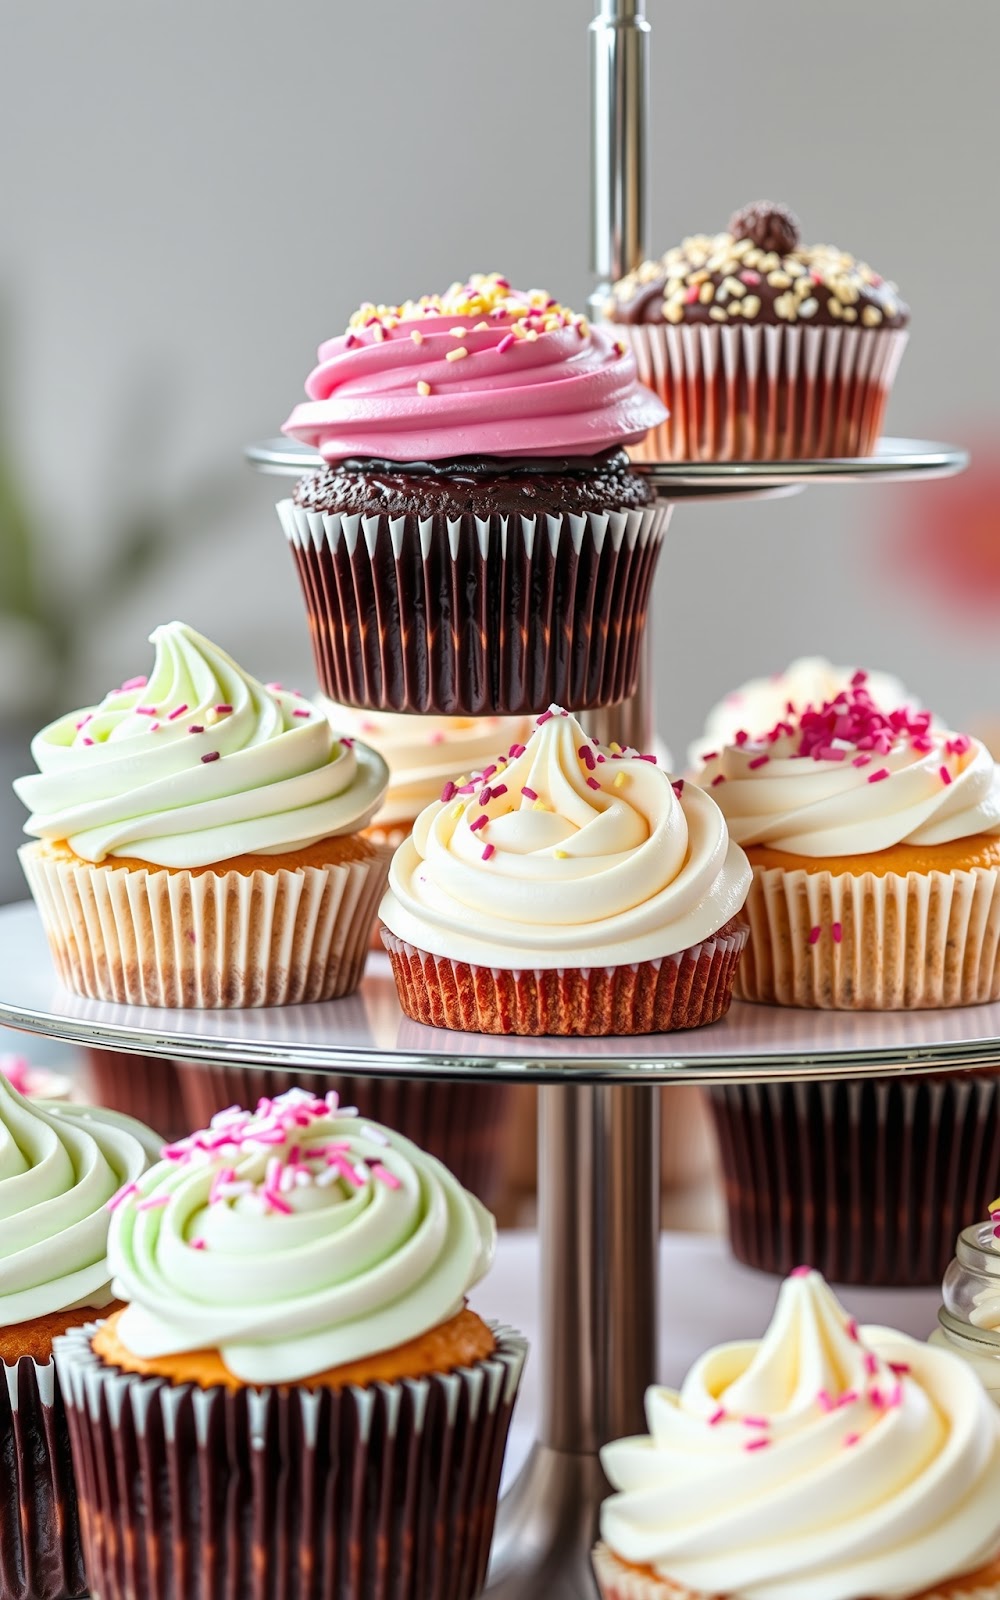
379, 707, 749, 1034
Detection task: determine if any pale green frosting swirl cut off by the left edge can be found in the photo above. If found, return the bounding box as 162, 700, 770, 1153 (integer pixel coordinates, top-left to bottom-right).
0, 1075, 160, 1328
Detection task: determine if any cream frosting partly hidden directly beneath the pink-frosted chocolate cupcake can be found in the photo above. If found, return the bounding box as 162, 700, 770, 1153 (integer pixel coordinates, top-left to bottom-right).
315, 694, 533, 829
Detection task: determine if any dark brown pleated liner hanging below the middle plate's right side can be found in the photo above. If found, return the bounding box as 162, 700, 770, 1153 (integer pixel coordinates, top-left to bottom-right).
709, 1069, 1000, 1288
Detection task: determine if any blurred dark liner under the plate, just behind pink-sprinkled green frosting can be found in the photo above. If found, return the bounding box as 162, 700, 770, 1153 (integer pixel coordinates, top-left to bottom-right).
178, 1062, 514, 1206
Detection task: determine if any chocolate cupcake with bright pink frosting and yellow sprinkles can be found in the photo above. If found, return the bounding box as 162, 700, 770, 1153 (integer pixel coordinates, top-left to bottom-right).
278, 275, 667, 717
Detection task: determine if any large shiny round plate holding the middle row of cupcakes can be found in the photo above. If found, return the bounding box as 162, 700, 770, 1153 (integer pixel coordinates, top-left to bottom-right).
0, 902, 1000, 1083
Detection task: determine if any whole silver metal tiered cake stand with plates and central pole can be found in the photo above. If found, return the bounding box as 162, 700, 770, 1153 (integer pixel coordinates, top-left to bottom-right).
0, 0, 979, 1600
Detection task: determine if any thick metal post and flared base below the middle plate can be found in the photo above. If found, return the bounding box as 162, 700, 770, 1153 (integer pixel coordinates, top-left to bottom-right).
485, 1083, 661, 1600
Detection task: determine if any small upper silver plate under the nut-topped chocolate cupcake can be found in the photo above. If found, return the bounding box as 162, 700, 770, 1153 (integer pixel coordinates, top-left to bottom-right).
245, 438, 968, 499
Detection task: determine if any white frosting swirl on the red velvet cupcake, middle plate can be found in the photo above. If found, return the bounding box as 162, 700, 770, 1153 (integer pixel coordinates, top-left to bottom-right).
379, 707, 750, 970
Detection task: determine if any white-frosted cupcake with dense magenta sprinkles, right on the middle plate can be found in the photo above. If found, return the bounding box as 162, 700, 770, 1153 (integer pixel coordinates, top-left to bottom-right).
699, 672, 1000, 1011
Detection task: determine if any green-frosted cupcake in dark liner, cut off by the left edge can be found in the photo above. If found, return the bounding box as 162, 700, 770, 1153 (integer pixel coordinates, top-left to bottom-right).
0, 1077, 158, 1600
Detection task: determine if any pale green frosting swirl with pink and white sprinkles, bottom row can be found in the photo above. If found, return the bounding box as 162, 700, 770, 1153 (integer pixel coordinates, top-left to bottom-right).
109, 1090, 496, 1384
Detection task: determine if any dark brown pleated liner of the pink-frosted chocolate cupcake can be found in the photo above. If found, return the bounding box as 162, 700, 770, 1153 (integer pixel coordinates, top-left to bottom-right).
278, 499, 669, 717
